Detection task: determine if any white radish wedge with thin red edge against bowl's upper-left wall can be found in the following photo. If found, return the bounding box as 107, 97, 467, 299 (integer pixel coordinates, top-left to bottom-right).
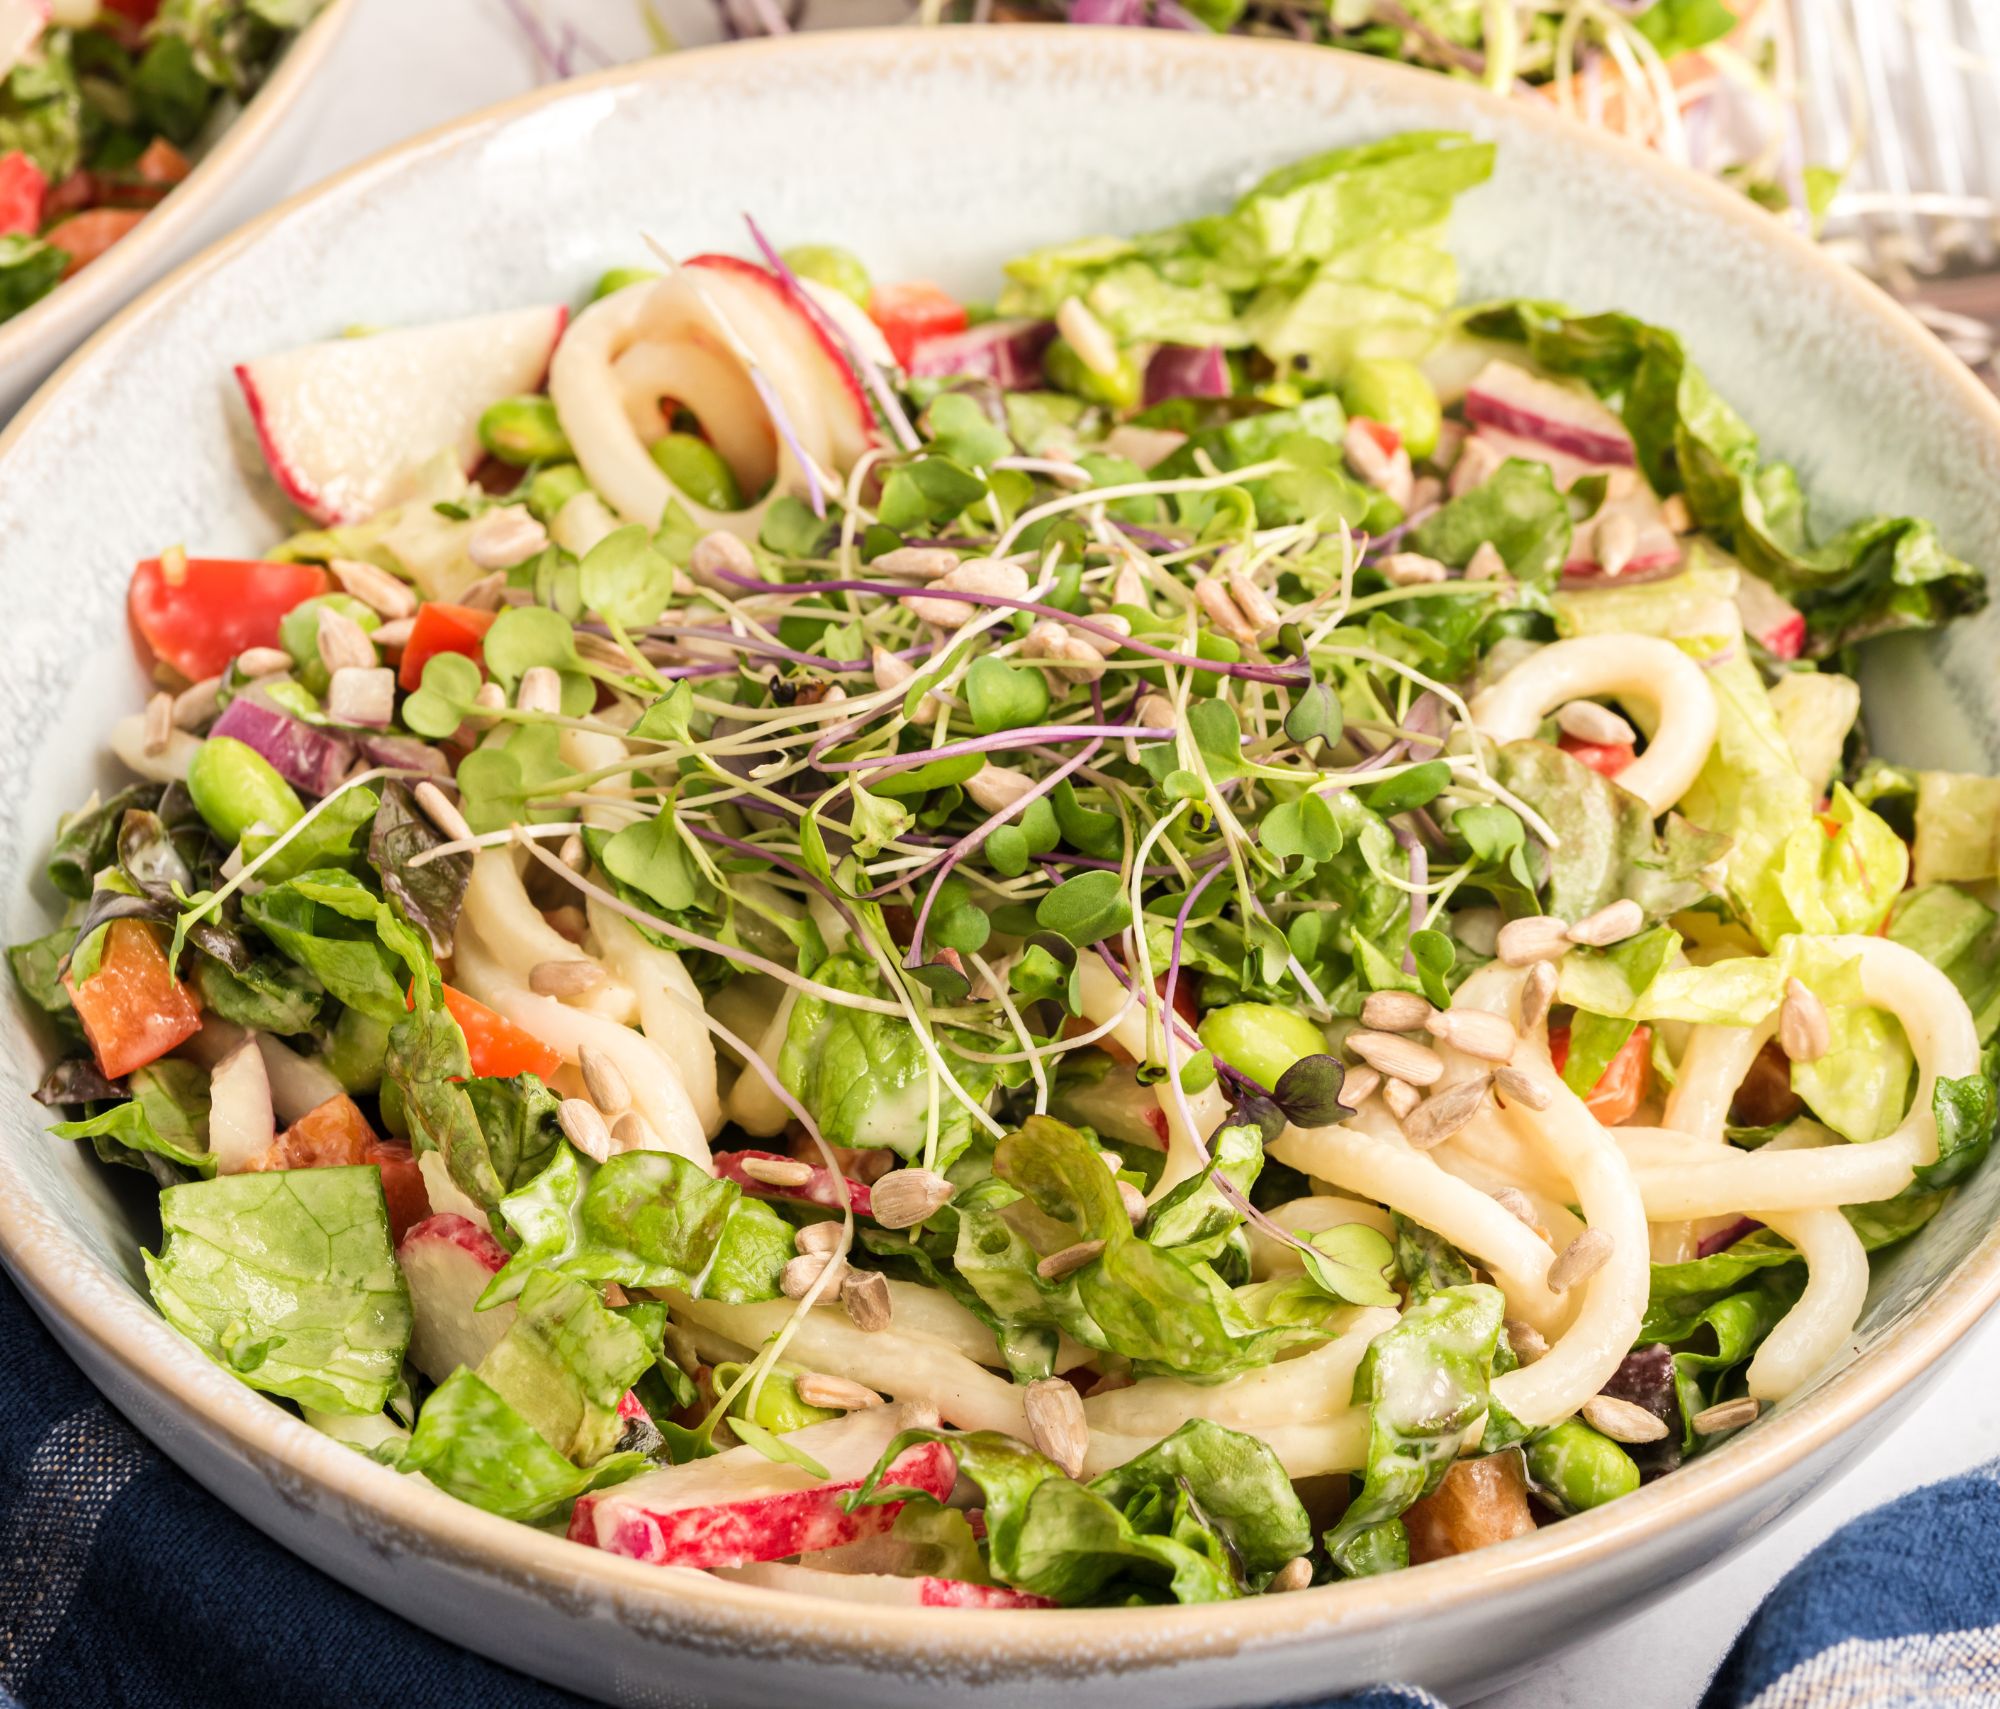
236, 304, 568, 524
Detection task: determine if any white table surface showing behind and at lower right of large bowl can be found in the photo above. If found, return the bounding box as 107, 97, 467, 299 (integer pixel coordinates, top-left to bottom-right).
258, 0, 2000, 1709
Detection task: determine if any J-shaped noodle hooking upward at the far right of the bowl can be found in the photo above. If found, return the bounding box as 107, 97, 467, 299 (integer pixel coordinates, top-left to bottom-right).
1636, 937, 1980, 1221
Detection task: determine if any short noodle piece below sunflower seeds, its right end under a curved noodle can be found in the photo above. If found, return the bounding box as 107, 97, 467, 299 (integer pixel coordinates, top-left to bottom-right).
1270, 1111, 1568, 1335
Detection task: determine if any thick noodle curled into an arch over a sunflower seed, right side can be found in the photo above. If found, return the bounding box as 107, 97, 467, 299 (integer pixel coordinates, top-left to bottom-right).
1470, 634, 1716, 814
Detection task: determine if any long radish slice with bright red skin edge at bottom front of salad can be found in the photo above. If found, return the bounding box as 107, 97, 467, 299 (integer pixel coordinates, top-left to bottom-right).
570, 1405, 958, 1567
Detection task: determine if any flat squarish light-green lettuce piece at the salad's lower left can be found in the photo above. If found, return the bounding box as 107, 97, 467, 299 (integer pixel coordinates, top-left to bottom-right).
144, 1167, 410, 1413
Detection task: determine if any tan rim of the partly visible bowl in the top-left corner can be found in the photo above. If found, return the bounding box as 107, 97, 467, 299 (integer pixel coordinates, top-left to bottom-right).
0, 0, 360, 382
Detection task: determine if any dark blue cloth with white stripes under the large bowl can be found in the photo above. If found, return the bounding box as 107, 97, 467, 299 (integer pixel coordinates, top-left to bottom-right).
0, 1273, 2000, 1709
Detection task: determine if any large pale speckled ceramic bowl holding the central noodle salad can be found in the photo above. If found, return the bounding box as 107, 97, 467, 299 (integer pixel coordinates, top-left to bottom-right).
0, 28, 2000, 1709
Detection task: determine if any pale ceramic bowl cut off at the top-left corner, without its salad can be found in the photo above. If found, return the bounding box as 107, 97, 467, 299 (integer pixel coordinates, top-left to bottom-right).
0, 0, 360, 422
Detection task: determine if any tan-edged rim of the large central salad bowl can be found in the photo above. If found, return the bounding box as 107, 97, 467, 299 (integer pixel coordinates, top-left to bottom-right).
0, 23, 2000, 1683
